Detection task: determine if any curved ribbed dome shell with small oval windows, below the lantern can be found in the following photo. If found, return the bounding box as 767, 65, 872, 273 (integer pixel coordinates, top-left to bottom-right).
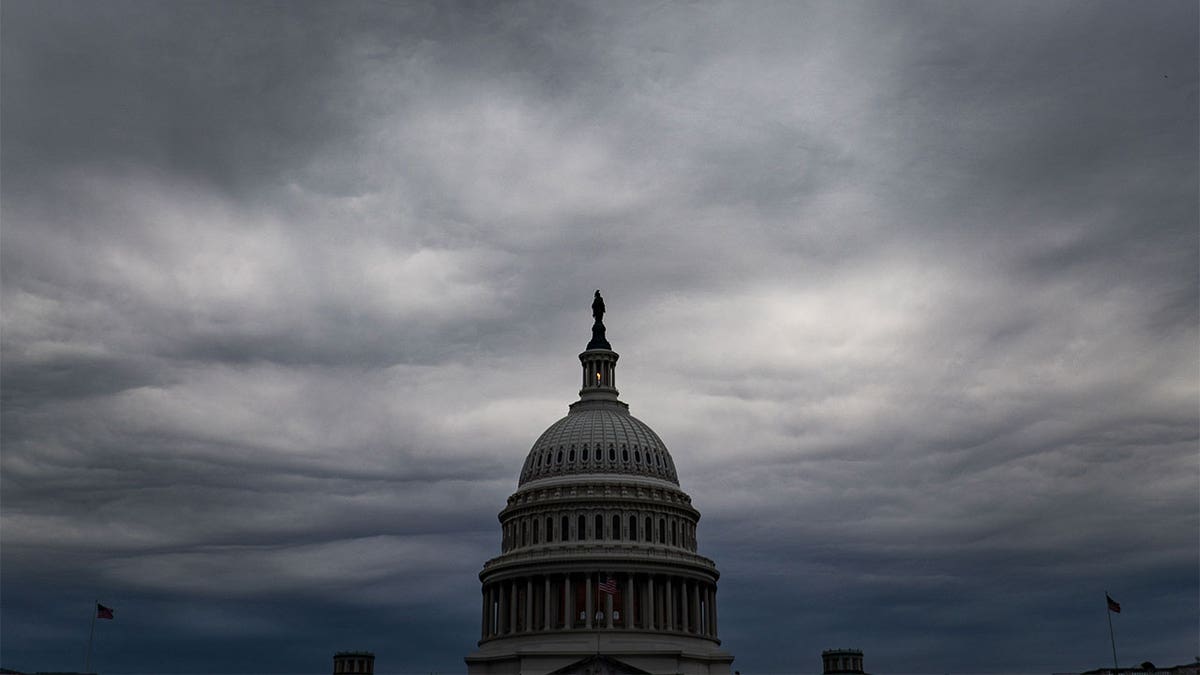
518, 401, 679, 485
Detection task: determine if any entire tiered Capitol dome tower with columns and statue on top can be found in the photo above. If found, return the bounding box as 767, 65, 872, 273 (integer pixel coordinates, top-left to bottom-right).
466, 291, 733, 675
